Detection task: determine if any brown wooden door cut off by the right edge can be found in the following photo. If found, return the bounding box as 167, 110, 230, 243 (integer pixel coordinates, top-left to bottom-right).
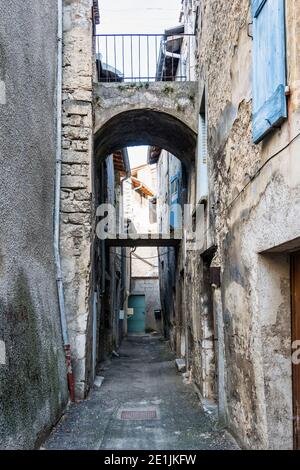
291, 251, 300, 450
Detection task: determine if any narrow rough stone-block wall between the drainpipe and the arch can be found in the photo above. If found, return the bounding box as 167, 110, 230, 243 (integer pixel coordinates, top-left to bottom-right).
61, 0, 94, 397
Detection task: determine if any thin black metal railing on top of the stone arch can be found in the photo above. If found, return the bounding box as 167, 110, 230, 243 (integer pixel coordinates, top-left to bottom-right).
95, 30, 194, 83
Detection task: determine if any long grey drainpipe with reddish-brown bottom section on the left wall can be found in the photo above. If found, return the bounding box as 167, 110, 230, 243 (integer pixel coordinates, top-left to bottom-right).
54, 0, 75, 401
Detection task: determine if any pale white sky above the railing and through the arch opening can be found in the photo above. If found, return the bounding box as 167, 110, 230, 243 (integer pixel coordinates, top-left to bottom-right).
97, 0, 181, 168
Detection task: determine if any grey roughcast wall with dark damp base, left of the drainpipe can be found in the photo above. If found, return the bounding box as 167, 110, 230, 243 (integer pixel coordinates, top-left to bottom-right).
0, 0, 68, 450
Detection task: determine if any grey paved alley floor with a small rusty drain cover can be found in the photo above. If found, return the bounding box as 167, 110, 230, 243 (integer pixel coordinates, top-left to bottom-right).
43, 336, 237, 450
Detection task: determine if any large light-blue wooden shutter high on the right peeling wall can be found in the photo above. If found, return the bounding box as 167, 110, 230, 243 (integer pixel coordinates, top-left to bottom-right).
252, 0, 287, 143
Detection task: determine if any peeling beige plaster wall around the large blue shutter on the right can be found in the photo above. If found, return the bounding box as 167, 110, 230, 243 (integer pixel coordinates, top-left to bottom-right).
199, 0, 300, 449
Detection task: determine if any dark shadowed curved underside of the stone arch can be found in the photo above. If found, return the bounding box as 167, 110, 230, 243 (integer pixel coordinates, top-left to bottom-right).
95, 109, 197, 167
